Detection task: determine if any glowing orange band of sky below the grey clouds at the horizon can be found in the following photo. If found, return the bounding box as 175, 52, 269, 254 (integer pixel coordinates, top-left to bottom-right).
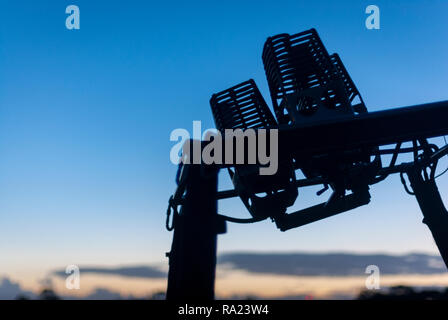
6, 269, 448, 299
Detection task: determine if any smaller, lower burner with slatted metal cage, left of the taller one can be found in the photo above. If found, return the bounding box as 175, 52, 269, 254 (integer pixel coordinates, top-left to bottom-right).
210, 79, 298, 219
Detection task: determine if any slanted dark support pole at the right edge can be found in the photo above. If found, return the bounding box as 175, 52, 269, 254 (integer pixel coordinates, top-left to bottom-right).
406, 166, 448, 267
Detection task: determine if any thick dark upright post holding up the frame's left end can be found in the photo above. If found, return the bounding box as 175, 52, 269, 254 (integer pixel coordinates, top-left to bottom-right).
167, 164, 225, 301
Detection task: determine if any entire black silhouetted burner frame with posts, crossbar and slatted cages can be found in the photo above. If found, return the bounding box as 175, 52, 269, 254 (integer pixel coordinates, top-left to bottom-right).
167, 29, 448, 300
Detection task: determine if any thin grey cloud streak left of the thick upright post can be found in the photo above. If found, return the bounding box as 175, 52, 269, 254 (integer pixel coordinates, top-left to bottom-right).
52, 266, 167, 279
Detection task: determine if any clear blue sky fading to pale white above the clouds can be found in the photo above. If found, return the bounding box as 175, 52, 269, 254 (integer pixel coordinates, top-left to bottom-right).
0, 0, 448, 296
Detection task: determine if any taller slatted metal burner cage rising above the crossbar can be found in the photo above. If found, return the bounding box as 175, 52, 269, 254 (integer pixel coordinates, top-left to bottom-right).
262, 29, 366, 125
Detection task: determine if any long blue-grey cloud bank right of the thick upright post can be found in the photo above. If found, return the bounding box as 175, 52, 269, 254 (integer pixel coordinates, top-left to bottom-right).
218, 252, 446, 276
